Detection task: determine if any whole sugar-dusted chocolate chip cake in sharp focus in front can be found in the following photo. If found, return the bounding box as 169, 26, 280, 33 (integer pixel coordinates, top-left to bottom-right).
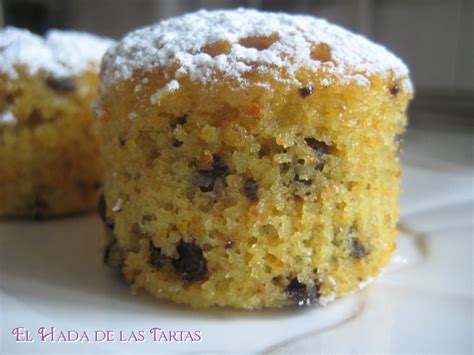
100, 9, 412, 309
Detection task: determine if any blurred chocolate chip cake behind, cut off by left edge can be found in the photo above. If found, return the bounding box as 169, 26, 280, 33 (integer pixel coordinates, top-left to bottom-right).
0, 27, 112, 218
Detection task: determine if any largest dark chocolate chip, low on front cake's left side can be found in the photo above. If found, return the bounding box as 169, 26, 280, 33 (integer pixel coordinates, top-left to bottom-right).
172, 240, 207, 282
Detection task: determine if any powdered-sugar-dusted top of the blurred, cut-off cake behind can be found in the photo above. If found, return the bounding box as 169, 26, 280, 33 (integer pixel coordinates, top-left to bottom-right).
0, 27, 114, 78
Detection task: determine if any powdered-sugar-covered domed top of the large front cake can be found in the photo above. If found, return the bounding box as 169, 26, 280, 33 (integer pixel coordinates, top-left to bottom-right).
101, 8, 412, 91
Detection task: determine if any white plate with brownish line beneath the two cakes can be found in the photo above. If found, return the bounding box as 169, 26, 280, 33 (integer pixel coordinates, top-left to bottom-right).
0, 121, 474, 354
